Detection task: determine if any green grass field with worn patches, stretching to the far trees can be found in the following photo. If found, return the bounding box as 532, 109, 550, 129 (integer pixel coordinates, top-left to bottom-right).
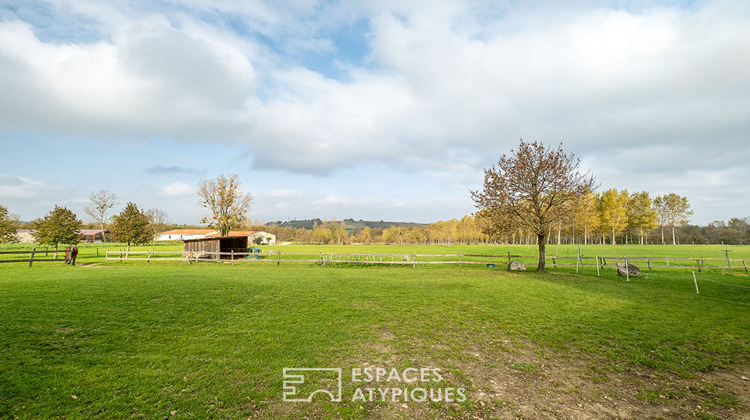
0, 245, 750, 418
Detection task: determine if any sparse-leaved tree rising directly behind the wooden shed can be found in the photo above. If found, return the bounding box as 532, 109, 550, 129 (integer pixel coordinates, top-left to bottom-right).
198, 174, 253, 236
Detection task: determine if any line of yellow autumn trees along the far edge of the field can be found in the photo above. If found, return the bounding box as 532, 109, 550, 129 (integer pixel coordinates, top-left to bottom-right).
256, 188, 750, 245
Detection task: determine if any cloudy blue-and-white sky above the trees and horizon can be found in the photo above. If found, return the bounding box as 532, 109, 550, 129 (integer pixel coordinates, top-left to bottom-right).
0, 0, 750, 225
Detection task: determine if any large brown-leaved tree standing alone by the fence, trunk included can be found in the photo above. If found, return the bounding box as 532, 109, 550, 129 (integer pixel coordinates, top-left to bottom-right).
471, 140, 594, 271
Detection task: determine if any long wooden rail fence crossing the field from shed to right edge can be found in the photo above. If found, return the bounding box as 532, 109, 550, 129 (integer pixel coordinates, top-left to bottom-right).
105, 250, 748, 274
